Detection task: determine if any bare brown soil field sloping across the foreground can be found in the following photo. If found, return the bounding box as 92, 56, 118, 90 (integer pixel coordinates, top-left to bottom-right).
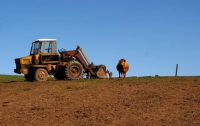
0, 77, 200, 126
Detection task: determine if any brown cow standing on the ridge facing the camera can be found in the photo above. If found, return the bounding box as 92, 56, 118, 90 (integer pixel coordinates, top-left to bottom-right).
116, 59, 129, 78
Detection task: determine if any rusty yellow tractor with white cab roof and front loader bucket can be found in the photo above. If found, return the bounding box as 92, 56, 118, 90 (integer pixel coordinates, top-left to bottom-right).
14, 39, 108, 81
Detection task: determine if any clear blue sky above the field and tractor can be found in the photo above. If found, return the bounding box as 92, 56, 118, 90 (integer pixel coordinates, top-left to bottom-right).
0, 0, 200, 77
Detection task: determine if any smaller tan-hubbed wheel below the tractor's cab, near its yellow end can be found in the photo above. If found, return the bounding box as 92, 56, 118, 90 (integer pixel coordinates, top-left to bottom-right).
35, 68, 48, 81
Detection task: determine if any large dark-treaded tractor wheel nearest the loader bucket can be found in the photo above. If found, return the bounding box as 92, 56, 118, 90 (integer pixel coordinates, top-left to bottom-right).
65, 60, 84, 80
